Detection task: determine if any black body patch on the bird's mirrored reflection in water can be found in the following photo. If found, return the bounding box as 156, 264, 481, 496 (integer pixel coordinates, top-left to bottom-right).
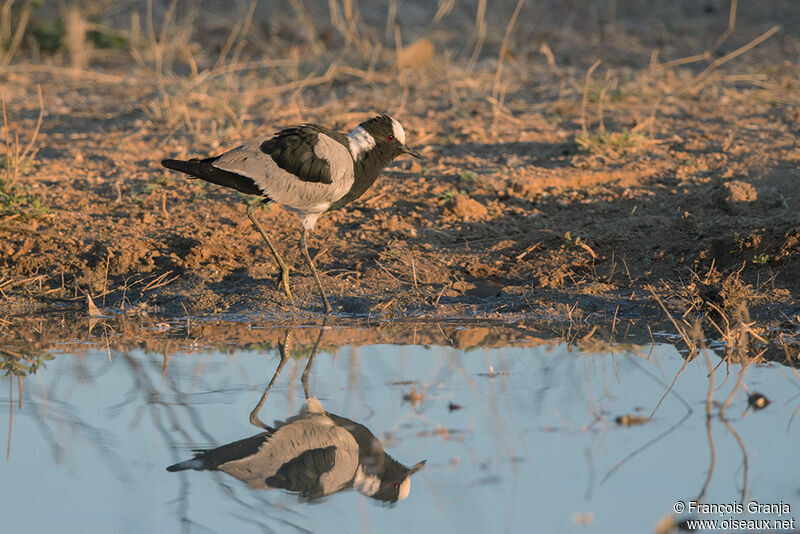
265, 445, 336, 499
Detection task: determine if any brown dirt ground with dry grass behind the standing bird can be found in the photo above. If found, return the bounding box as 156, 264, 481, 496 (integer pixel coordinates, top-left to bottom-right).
0, 0, 800, 356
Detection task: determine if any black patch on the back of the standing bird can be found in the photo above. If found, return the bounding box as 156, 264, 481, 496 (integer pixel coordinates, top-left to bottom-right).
261, 124, 346, 184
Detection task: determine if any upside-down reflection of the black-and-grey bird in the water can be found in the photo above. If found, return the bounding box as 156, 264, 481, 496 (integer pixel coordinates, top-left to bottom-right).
167, 324, 425, 503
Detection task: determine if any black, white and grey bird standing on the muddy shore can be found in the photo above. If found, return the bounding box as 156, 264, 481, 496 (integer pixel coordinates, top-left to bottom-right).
161, 114, 422, 314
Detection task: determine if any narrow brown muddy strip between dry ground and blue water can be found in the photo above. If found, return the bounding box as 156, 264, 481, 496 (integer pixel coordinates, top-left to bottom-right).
0, 312, 800, 374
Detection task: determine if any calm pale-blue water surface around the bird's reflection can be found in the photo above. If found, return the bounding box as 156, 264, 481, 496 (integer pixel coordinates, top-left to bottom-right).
0, 324, 800, 533
